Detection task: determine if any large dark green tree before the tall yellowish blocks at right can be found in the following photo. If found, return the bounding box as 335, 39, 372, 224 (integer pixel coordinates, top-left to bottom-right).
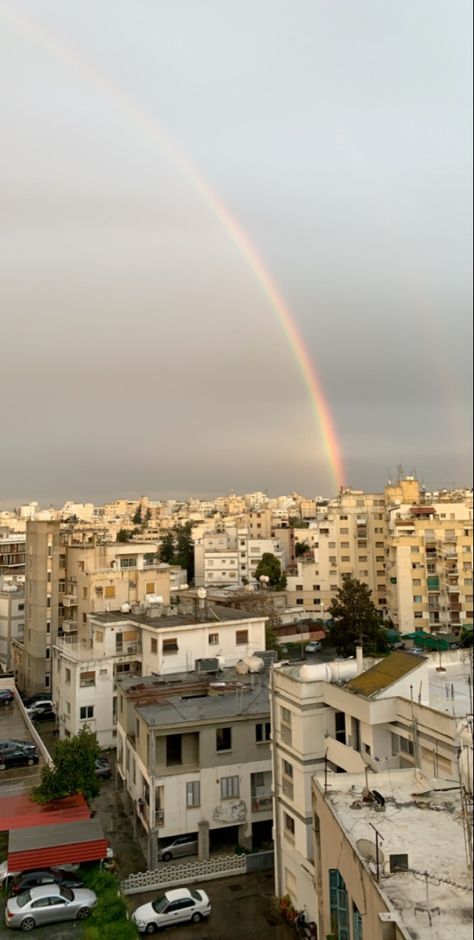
328, 575, 388, 655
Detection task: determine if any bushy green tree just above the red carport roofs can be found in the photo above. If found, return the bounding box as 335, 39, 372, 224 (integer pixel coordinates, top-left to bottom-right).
33, 727, 100, 803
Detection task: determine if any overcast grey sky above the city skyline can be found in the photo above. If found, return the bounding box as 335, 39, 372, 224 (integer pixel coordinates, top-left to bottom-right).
0, 0, 472, 505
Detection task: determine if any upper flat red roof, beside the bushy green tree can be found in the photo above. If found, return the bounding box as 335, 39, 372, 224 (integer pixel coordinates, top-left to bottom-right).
0, 793, 91, 832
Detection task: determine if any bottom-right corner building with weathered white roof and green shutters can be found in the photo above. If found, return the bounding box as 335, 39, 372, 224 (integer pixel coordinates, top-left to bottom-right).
312, 769, 472, 940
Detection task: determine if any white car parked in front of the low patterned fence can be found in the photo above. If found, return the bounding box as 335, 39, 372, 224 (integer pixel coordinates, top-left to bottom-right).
132, 888, 211, 933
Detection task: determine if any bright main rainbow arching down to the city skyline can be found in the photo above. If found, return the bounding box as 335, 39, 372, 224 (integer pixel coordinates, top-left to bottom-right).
0, 4, 344, 489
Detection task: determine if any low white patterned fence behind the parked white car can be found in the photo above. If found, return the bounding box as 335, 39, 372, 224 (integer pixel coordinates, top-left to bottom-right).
121, 852, 273, 894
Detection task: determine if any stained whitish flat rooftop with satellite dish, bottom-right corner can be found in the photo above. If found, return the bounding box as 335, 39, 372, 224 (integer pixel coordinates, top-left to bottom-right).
316, 770, 473, 940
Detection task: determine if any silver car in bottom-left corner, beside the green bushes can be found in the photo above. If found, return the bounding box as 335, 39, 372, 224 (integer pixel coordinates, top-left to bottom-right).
5, 884, 97, 930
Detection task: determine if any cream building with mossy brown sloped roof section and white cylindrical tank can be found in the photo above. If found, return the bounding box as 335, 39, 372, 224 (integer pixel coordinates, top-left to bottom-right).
271, 652, 469, 921
